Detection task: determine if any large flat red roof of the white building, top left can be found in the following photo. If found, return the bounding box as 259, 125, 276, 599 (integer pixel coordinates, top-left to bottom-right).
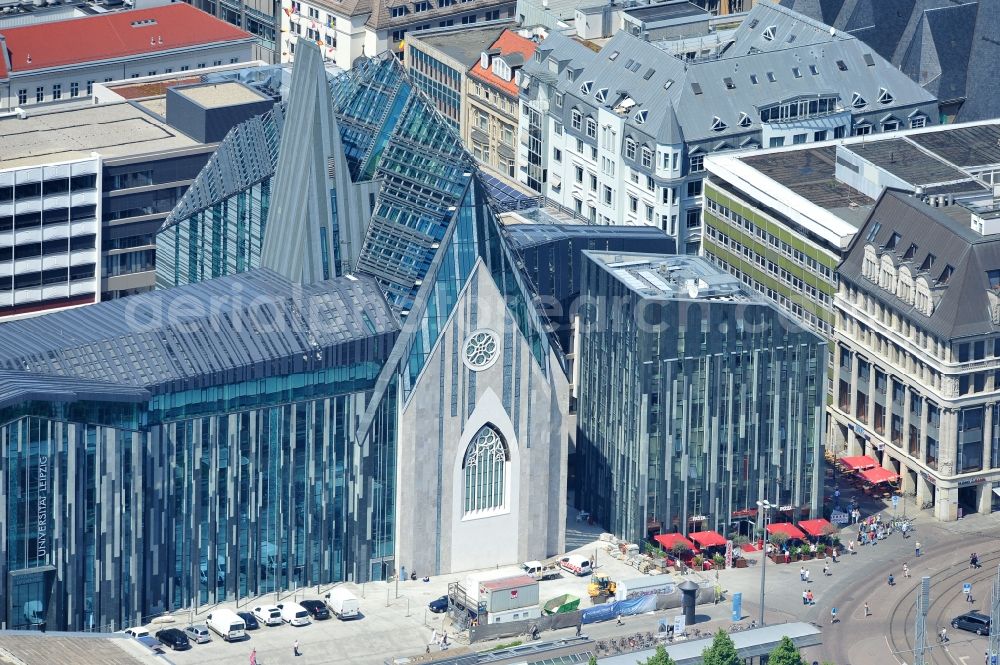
0, 2, 252, 78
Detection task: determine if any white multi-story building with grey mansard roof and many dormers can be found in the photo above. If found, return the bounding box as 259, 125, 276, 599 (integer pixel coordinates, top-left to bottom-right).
519, 2, 937, 253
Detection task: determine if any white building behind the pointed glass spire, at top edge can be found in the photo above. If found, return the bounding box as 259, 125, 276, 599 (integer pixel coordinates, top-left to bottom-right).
281, 0, 516, 69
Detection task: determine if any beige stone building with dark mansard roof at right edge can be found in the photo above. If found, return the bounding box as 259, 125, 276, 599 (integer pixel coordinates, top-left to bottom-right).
829, 189, 1000, 521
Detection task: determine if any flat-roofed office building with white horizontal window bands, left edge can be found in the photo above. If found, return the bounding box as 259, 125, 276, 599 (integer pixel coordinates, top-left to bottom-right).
0, 76, 274, 320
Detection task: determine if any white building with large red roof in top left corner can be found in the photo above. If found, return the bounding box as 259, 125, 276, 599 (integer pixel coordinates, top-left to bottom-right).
0, 2, 253, 110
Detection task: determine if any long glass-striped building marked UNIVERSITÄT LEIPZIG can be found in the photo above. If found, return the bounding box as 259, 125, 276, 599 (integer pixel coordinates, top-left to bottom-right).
0, 270, 398, 630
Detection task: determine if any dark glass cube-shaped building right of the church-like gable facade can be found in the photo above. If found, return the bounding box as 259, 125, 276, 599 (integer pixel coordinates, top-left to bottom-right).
576, 251, 826, 542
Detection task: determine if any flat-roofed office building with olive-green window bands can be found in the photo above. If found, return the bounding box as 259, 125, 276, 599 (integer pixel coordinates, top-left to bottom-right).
704, 121, 1000, 339
